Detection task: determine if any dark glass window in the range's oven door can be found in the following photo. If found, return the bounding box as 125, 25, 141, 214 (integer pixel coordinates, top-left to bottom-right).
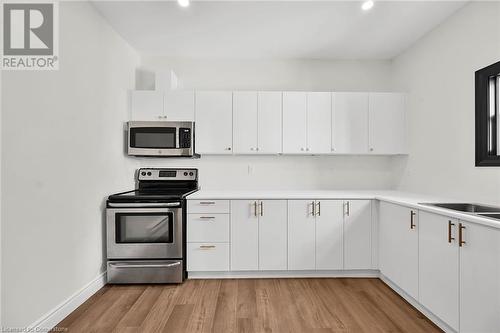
115, 212, 174, 243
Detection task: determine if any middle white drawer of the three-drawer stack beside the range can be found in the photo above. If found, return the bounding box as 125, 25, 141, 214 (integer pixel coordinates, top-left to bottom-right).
187, 214, 229, 242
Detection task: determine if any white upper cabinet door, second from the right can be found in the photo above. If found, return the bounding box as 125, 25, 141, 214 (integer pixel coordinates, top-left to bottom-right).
332, 93, 368, 154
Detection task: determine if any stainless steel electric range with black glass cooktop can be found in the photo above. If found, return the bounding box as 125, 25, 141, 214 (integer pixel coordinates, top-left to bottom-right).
106, 168, 198, 283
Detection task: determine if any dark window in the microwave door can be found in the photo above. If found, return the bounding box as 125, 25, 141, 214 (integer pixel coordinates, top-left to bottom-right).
130, 127, 176, 149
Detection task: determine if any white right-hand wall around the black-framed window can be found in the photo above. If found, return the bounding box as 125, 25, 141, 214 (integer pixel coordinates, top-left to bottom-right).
393, 2, 500, 205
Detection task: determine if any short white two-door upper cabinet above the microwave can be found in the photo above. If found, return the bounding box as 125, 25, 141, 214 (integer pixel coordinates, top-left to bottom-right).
131, 90, 194, 121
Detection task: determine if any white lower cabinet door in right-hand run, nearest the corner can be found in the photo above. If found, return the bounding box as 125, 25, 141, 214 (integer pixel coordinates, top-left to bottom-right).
379, 202, 419, 299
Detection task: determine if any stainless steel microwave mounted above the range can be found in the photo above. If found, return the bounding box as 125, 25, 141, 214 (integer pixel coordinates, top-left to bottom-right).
128, 121, 195, 157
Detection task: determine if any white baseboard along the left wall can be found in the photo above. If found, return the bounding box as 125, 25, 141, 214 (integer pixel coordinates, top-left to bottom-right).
27, 272, 106, 332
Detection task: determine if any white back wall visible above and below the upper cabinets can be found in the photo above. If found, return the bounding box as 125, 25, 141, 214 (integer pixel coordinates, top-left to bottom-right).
137, 57, 404, 189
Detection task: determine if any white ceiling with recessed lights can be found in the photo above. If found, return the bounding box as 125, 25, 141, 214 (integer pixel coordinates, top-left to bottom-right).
94, 1, 464, 59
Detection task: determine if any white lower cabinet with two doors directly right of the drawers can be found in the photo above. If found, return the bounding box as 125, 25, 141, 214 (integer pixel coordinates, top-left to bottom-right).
231, 200, 287, 271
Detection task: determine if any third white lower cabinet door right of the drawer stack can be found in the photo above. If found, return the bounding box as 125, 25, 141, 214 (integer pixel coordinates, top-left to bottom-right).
288, 200, 316, 270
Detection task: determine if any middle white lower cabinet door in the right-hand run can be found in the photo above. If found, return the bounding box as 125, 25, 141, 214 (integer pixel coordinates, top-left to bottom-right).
418, 211, 458, 330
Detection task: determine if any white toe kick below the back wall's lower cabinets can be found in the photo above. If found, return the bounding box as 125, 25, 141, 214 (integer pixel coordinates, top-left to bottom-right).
188, 269, 380, 279
